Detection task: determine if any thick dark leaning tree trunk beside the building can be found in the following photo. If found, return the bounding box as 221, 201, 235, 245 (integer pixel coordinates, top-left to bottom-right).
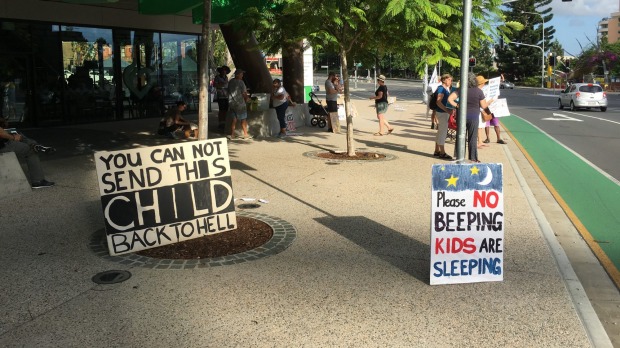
220, 24, 272, 93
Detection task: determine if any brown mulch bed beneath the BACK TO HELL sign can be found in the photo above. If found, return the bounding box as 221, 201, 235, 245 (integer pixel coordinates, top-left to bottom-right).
136, 216, 273, 260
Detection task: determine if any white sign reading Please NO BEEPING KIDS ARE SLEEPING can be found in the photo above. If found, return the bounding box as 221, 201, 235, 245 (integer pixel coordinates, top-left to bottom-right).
430, 163, 505, 285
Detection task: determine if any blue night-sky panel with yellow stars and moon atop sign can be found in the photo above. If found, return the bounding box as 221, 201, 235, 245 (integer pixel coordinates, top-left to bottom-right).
432, 163, 504, 192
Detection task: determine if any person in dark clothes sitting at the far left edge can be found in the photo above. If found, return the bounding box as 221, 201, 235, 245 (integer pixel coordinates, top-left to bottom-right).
0, 119, 56, 189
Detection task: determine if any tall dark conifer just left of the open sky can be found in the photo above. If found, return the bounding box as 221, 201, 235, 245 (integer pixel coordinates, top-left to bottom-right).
496, 0, 555, 80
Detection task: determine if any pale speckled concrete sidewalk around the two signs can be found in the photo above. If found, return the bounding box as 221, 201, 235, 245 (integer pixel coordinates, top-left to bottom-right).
0, 101, 611, 347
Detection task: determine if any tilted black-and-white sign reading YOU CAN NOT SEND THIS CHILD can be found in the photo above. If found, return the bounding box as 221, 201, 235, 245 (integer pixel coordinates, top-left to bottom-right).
95, 139, 237, 255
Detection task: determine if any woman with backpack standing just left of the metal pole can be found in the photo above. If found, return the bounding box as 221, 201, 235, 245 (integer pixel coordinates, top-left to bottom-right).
429, 74, 452, 160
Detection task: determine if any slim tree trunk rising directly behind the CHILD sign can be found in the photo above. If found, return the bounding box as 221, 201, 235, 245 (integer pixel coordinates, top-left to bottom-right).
198, 0, 211, 140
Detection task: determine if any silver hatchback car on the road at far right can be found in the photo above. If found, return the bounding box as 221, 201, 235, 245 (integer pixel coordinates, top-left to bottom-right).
558, 83, 607, 111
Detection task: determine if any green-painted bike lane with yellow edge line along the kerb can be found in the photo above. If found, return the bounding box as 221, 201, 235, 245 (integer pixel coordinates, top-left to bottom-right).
500, 115, 620, 288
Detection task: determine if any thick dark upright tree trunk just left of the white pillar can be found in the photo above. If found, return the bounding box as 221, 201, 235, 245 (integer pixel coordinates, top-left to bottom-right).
282, 41, 304, 104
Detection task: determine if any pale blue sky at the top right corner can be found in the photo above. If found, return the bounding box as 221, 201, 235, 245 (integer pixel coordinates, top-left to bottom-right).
538, 0, 620, 56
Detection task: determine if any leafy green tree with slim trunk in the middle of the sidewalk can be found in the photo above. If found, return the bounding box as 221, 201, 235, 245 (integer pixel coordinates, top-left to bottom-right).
238, 0, 516, 155
